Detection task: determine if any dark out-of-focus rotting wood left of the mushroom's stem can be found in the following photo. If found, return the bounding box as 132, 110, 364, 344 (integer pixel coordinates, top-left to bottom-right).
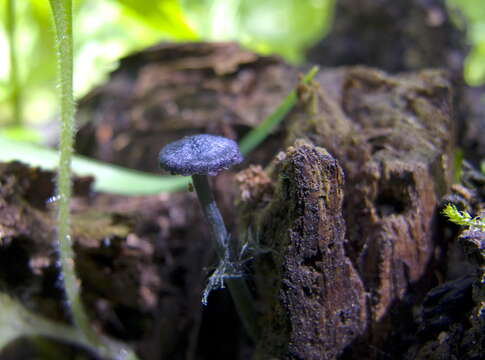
0, 163, 214, 359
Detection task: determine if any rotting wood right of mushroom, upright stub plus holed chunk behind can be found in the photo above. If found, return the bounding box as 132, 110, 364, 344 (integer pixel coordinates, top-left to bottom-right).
239, 67, 453, 359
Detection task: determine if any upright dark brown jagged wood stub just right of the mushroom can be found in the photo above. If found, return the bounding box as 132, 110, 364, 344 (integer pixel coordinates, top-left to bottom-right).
239, 141, 367, 360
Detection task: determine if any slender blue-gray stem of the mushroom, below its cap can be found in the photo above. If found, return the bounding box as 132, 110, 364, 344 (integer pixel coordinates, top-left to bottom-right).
192, 174, 259, 341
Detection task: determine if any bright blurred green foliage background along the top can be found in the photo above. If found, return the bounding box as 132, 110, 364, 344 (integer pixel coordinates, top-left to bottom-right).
0, 0, 485, 131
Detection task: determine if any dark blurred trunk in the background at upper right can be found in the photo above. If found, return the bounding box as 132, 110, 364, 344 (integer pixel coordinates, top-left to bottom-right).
308, 0, 485, 169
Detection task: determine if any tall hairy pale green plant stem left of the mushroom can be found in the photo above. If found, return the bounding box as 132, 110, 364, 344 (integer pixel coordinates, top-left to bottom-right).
50, 0, 96, 342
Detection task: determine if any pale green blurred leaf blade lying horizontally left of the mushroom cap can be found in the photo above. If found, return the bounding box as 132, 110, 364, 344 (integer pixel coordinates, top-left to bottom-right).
0, 135, 189, 195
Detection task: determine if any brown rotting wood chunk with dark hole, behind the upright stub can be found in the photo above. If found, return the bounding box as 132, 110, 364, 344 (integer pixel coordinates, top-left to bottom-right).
296, 68, 452, 336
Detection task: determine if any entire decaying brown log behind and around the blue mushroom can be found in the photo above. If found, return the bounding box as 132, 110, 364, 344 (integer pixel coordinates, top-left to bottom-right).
0, 44, 462, 360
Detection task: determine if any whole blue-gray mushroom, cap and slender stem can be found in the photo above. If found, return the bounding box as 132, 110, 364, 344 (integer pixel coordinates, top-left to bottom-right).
159, 134, 259, 340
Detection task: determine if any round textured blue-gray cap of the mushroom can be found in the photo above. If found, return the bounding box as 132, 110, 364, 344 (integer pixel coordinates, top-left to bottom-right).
159, 134, 243, 176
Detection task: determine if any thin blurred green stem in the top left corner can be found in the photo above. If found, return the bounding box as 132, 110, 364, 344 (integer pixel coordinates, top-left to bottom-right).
5, 0, 22, 126
